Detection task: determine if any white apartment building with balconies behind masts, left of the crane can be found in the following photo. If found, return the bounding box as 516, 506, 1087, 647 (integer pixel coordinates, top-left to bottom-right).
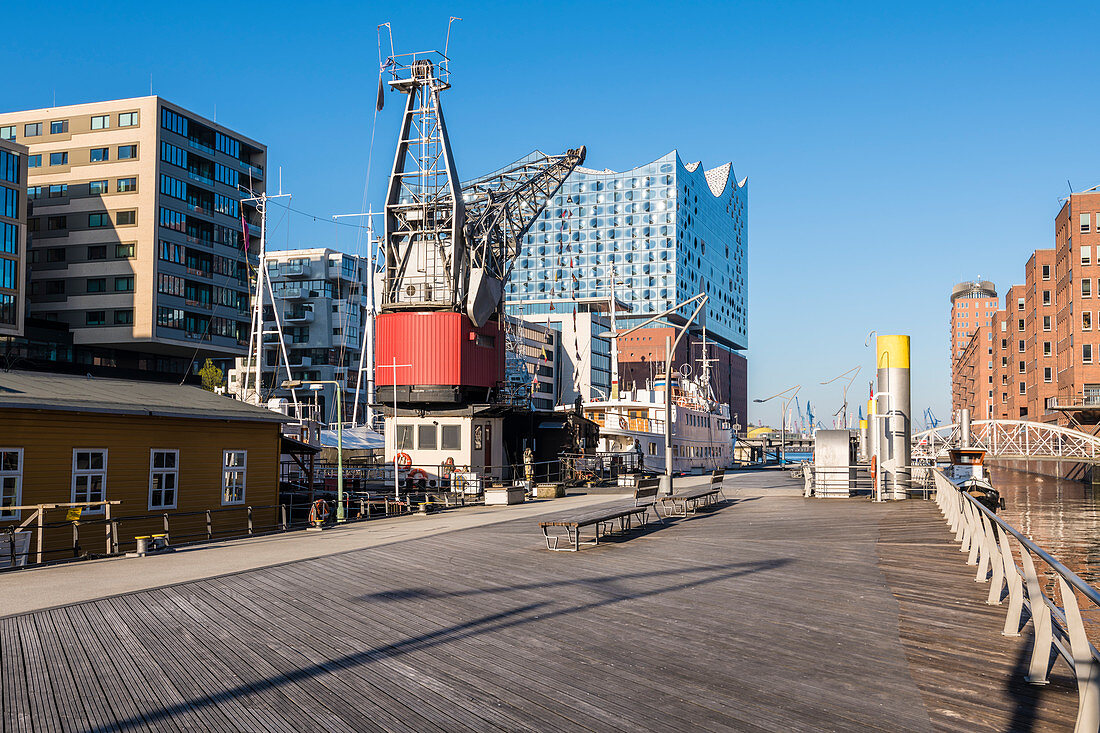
229, 248, 370, 424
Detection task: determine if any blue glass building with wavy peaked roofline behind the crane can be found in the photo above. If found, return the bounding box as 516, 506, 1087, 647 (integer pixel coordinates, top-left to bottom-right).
505, 151, 748, 405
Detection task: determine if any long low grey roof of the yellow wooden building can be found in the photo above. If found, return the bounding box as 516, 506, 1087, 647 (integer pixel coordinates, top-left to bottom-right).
0, 371, 287, 423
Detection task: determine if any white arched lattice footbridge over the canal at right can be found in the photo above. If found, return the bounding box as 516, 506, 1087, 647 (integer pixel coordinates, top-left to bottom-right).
913, 420, 1100, 463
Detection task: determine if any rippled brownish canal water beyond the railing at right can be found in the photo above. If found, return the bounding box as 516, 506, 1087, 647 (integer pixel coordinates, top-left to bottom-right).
987, 464, 1100, 587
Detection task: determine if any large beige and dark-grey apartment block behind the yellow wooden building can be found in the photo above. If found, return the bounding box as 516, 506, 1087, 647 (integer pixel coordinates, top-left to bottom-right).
0, 97, 266, 373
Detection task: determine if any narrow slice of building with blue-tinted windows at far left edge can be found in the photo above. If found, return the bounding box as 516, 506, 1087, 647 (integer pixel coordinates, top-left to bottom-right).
0, 139, 28, 338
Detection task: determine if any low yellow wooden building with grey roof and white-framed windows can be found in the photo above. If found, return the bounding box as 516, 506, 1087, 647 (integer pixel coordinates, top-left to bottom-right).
0, 371, 286, 554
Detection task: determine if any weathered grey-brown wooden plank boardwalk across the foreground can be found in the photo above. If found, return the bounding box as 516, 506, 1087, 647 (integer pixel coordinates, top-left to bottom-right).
0, 473, 1076, 733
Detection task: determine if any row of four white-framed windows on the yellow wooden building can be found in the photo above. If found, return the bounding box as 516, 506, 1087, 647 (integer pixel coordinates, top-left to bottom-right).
0, 448, 249, 519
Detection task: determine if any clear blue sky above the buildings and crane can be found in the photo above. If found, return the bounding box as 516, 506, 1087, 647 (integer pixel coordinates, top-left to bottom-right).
0, 1, 1100, 422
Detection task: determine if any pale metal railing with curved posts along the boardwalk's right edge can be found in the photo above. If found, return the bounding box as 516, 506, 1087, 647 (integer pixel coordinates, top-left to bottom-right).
934, 470, 1100, 733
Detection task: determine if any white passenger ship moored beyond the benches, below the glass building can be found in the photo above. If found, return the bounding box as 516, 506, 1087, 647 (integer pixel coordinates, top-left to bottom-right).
582, 380, 734, 473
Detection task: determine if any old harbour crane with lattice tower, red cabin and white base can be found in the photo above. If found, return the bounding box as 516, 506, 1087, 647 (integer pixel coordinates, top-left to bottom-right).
375, 51, 585, 479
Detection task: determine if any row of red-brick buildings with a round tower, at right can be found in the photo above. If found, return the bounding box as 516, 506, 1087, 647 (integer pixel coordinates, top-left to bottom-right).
950, 190, 1100, 425
